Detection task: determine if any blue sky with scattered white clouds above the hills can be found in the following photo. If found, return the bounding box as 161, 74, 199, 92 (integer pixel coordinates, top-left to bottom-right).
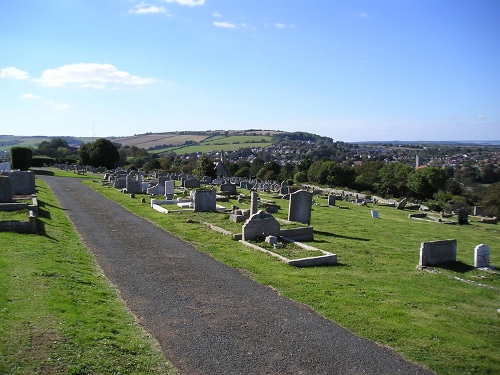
0, 0, 500, 141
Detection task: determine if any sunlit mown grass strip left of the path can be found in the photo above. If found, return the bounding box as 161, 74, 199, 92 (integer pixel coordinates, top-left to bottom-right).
0, 179, 174, 374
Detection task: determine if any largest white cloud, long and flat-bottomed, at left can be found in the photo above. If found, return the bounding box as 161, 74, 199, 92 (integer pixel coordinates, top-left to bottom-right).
34, 63, 154, 89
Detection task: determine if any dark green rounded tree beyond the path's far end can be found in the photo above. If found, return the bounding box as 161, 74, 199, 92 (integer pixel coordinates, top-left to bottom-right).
79, 138, 120, 169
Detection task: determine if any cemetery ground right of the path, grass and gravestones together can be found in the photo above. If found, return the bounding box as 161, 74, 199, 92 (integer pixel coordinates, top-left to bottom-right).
1, 171, 500, 373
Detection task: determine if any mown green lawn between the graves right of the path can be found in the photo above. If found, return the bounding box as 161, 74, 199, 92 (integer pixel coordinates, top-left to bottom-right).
86, 181, 500, 374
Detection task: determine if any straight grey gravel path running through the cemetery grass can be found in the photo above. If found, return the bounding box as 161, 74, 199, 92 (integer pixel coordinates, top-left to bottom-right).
38, 176, 430, 375
